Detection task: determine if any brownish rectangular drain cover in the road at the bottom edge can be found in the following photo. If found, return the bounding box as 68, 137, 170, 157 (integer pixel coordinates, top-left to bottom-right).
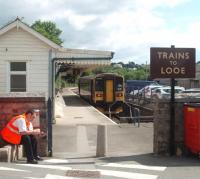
66, 170, 101, 178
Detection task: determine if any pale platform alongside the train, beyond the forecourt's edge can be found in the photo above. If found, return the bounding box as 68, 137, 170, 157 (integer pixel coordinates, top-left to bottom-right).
56, 88, 116, 125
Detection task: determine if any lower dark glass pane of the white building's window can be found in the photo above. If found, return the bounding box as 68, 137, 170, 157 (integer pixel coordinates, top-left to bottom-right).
10, 75, 26, 92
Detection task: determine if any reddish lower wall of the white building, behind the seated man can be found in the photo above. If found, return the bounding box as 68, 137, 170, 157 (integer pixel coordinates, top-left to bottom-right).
0, 97, 47, 156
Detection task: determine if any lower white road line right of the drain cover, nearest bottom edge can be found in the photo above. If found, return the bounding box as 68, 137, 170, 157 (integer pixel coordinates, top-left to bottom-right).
99, 170, 158, 179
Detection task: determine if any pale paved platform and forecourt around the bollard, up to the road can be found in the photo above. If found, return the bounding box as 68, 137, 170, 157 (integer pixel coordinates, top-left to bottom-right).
52, 88, 153, 158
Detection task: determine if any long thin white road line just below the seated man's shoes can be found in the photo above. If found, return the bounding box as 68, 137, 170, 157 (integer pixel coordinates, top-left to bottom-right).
16, 164, 71, 171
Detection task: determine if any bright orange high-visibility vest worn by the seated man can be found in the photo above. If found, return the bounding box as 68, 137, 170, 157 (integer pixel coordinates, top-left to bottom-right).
1, 114, 30, 144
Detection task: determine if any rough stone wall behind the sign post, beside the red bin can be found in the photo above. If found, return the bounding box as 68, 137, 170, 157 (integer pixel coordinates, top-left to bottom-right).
153, 99, 200, 156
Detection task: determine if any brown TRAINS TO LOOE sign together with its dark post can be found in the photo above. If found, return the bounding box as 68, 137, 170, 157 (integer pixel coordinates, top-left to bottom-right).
150, 45, 195, 155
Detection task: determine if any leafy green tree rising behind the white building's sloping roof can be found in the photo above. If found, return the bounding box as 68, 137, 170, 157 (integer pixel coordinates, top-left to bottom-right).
31, 20, 63, 45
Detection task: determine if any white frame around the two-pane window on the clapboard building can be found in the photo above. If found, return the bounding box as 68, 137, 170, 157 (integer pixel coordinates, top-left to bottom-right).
7, 61, 29, 93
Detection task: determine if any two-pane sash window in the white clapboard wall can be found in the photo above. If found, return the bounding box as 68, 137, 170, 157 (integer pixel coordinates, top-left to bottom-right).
10, 62, 27, 92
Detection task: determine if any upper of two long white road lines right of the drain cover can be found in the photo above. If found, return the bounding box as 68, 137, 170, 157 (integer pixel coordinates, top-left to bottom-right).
101, 163, 167, 171
